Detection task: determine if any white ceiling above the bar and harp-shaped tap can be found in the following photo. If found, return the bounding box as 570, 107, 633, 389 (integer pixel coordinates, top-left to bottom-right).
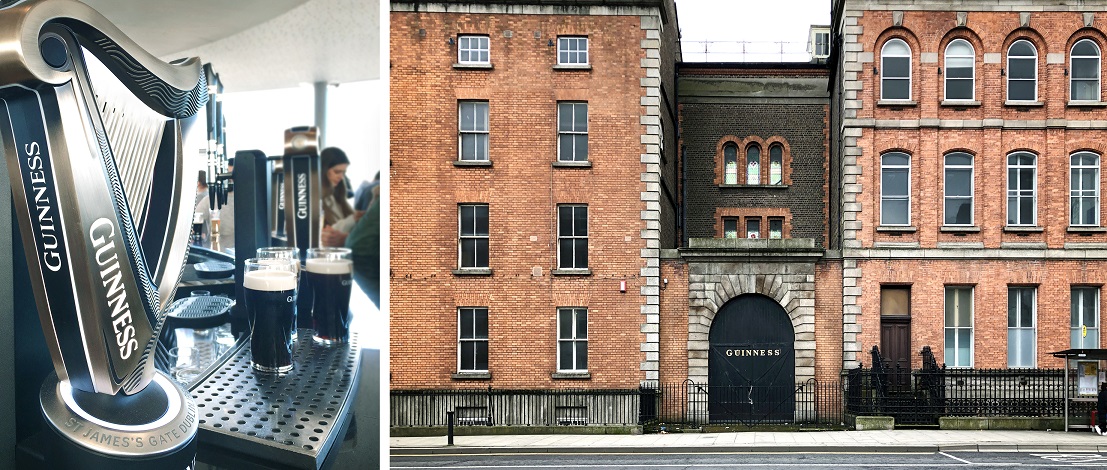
84, 0, 381, 92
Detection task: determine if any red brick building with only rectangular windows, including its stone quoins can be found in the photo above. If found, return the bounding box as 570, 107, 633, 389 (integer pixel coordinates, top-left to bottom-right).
390, 0, 680, 400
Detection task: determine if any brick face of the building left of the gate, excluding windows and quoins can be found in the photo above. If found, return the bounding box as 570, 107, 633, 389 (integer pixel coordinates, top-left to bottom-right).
390, 12, 645, 388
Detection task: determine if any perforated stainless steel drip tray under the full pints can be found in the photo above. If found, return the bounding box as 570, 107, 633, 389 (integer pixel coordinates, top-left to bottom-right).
190, 330, 361, 469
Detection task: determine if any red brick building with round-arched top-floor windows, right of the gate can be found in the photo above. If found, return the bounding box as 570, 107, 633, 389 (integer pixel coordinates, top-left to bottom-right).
831, 0, 1107, 368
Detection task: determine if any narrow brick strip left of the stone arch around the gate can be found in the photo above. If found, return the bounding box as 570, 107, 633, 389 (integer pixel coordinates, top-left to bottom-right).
660, 260, 689, 384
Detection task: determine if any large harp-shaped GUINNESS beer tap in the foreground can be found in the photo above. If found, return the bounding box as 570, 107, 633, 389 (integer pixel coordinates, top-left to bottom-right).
0, 0, 207, 469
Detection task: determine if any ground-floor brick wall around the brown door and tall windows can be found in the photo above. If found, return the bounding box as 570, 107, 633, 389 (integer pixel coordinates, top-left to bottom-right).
859, 256, 1107, 368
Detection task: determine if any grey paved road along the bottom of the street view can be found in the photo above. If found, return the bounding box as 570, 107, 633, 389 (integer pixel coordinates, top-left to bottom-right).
391, 452, 1107, 470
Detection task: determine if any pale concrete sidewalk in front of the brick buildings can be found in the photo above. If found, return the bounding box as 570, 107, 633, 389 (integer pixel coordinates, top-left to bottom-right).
390, 429, 1107, 456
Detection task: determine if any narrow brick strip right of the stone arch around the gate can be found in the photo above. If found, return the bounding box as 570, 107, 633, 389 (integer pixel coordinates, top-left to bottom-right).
815, 260, 842, 382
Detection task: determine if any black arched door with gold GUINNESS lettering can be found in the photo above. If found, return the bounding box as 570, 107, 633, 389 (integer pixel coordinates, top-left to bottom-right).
707, 294, 796, 422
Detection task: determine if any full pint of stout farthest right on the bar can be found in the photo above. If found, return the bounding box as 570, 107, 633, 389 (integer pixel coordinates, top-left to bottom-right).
303, 248, 353, 344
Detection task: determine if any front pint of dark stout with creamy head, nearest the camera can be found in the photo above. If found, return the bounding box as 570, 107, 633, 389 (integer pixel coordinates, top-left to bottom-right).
242, 258, 299, 373
